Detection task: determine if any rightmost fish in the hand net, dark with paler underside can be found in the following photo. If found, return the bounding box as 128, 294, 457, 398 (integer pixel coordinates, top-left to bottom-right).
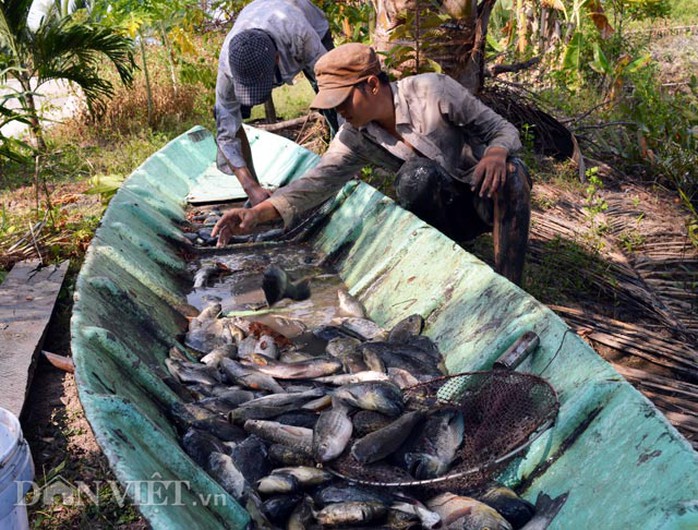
405, 410, 465, 480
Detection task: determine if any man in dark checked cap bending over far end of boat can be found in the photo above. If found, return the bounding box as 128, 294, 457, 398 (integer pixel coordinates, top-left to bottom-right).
214, 0, 337, 205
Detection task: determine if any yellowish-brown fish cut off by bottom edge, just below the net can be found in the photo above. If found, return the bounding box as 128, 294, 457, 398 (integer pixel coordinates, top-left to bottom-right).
426, 492, 512, 530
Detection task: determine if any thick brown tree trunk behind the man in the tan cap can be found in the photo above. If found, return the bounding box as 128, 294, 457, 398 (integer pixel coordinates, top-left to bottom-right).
373, 0, 496, 93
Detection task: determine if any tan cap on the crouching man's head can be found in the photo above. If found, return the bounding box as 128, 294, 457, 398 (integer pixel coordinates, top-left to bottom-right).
310, 42, 381, 109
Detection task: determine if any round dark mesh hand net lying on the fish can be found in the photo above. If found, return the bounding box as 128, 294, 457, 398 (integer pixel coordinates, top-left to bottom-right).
330, 369, 559, 490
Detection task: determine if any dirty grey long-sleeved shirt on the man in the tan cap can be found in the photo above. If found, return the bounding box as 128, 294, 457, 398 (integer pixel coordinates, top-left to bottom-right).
269, 74, 521, 226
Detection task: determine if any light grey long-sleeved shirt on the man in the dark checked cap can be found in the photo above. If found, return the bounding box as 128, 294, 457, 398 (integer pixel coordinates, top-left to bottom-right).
215, 0, 329, 174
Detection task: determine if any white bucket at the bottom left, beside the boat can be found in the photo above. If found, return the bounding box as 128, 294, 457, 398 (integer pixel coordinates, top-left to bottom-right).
0, 408, 34, 530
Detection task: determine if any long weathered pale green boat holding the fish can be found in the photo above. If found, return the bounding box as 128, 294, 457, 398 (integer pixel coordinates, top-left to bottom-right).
71, 127, 698, 530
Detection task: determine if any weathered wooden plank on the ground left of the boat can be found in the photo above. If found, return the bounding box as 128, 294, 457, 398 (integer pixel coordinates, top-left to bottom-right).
0, 260, 69, 416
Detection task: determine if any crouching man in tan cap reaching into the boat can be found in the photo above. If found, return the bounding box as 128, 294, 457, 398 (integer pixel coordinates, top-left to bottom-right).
213, 43, 531, 284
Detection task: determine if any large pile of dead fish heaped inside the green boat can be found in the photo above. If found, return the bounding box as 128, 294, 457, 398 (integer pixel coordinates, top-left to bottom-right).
166, 262, 548, 530
